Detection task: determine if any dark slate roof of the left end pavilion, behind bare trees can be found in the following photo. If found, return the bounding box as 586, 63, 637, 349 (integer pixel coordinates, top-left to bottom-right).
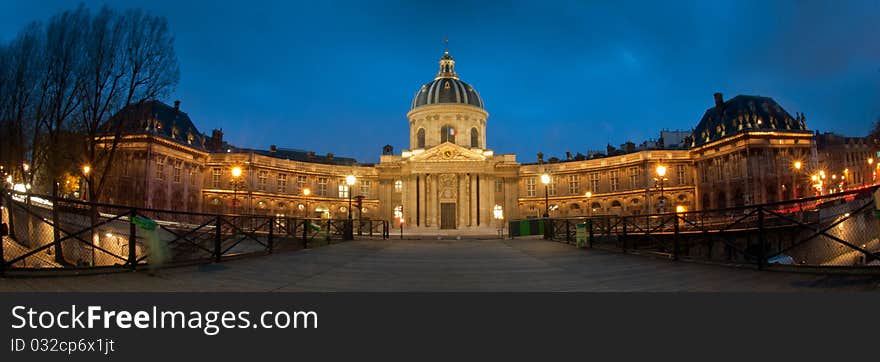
101, 101, 206, 151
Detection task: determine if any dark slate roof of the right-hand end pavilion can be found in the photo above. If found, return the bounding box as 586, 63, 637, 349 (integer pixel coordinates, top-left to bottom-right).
691, 93, 807, 147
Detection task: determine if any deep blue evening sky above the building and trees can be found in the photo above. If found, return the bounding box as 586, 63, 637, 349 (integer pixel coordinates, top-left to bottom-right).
0, 0, 880, 162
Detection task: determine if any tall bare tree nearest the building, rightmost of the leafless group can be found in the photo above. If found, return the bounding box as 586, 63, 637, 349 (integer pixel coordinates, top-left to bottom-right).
81, 8, 180, 204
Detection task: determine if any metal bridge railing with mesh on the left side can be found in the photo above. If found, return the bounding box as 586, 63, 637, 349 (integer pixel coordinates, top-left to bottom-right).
0, 191, 389, 273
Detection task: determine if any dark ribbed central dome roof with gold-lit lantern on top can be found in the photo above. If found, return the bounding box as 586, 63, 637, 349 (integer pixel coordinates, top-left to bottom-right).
411, 52, 483, 109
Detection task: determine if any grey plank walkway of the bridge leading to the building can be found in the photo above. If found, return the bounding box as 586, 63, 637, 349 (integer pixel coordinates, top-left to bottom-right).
0, 240, 880, 292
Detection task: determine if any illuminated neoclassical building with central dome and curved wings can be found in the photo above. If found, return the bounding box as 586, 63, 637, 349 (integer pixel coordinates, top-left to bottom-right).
93, 52, 844, 234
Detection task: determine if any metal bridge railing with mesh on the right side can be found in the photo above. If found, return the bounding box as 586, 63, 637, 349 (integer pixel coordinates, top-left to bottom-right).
516, 186, 880, 272
